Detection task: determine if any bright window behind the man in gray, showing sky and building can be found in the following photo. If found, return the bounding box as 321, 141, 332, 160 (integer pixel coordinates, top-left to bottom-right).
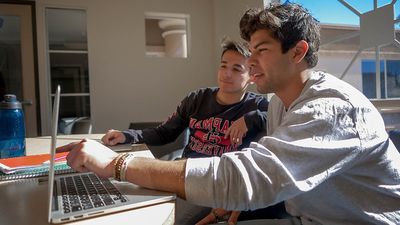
282, 0, 400, 99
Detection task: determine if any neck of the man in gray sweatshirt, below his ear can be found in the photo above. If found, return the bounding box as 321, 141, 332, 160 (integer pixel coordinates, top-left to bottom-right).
275, 69, 311, 109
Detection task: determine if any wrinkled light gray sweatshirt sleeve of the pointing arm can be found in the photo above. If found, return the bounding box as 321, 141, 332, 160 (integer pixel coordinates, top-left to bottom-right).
185, 96, 384, 210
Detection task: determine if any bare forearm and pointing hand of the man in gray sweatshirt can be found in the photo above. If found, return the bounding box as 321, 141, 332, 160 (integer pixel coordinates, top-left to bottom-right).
57, 139, 186, 198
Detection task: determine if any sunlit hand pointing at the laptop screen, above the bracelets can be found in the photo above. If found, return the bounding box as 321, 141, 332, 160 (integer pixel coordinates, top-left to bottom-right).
57, 139, 118, 177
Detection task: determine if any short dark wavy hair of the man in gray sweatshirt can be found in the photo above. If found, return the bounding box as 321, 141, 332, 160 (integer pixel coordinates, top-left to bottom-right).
240, 3, 320, 68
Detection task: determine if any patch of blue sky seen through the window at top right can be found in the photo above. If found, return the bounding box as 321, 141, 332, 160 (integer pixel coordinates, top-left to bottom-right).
281, 0, 400, 25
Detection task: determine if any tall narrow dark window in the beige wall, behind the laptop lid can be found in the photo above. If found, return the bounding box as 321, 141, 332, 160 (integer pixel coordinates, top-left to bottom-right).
46, 8, 91, 134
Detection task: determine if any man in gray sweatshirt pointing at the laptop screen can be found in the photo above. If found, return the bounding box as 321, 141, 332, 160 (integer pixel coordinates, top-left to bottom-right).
62, 4, 400, 225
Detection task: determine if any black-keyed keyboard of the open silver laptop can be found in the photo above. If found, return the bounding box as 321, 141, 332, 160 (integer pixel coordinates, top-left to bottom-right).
60, 173, 127, 213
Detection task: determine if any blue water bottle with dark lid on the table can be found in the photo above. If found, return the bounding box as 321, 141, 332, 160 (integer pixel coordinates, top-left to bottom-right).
0, 95, 25, 158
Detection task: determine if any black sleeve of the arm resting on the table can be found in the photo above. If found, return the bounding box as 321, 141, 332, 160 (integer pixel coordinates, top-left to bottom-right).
123, 92, 193, 145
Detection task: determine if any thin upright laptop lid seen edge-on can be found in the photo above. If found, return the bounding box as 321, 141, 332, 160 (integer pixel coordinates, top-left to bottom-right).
47, 85, 61, 223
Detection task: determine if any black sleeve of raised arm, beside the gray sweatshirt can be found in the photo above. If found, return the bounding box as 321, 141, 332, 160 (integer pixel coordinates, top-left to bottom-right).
244, 97, 268, 131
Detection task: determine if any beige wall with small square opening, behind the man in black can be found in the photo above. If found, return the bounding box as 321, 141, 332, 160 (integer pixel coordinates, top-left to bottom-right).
36, 0, 222, 133
